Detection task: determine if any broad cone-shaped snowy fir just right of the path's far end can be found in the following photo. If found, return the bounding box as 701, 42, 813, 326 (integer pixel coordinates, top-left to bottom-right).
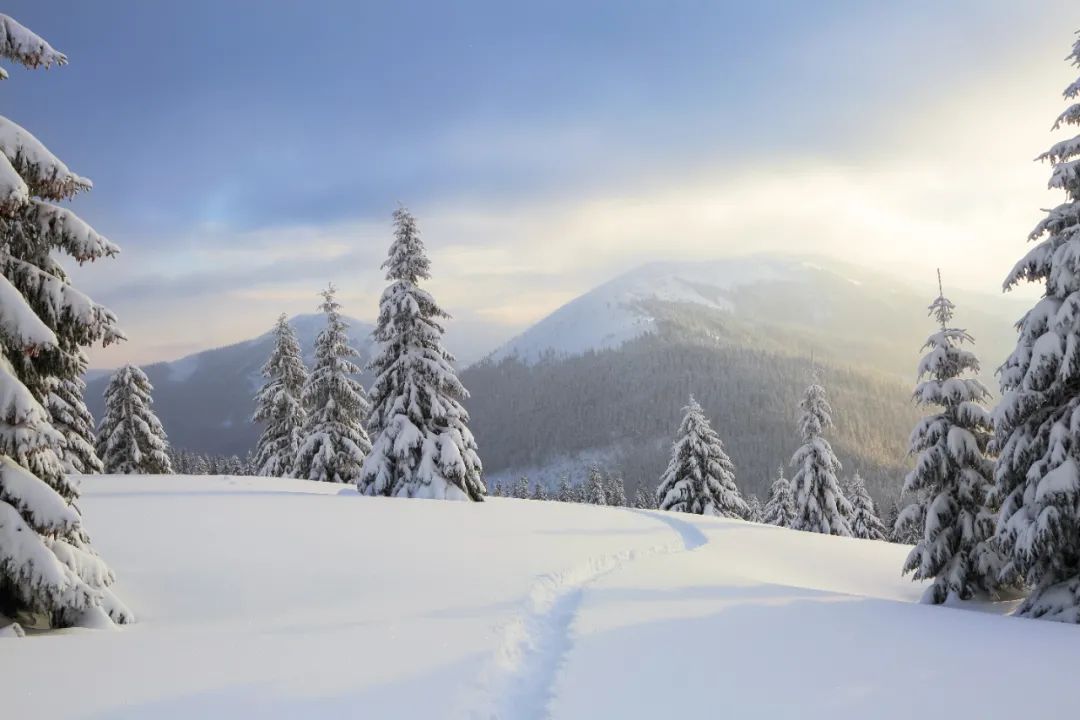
657, 395, 750, 518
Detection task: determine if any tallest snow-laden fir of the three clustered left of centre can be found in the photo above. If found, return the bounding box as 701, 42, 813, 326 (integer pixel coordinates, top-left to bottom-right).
359, 207, 486, 500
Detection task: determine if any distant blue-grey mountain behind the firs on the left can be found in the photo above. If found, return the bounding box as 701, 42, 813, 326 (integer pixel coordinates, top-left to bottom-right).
86, 313, 373, 456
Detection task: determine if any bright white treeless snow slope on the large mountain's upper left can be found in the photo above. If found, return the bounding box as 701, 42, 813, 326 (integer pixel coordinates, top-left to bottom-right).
490, 257, 805, 363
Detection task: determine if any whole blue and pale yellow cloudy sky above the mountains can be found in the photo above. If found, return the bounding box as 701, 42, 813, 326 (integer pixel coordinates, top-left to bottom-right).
0, 0, 1080, 367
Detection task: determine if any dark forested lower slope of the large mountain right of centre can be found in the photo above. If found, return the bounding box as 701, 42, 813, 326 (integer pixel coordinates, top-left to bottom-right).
462, 307, 917, 499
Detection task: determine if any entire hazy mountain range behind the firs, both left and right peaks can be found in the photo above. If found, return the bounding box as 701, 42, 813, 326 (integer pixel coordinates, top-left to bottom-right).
87, 256, 1020, 499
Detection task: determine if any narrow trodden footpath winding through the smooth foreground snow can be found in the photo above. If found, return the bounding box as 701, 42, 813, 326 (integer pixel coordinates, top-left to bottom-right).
461, 510, 708, 720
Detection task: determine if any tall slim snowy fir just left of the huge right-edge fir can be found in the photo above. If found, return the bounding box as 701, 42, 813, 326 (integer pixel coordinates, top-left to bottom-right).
896, 273, 1002, 604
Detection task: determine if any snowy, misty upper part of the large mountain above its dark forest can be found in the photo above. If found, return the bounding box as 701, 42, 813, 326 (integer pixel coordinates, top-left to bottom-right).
487, 256, 1025, 381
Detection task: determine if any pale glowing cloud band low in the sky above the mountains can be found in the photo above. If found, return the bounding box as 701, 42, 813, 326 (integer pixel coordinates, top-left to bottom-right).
78, 2, 1075, 364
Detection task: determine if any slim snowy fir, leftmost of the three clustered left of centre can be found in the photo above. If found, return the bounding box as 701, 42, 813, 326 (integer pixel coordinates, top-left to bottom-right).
253, 314, 308, 477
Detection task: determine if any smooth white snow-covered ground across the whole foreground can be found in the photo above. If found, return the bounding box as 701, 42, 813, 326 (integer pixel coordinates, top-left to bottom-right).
0, 476, 1080, 720
